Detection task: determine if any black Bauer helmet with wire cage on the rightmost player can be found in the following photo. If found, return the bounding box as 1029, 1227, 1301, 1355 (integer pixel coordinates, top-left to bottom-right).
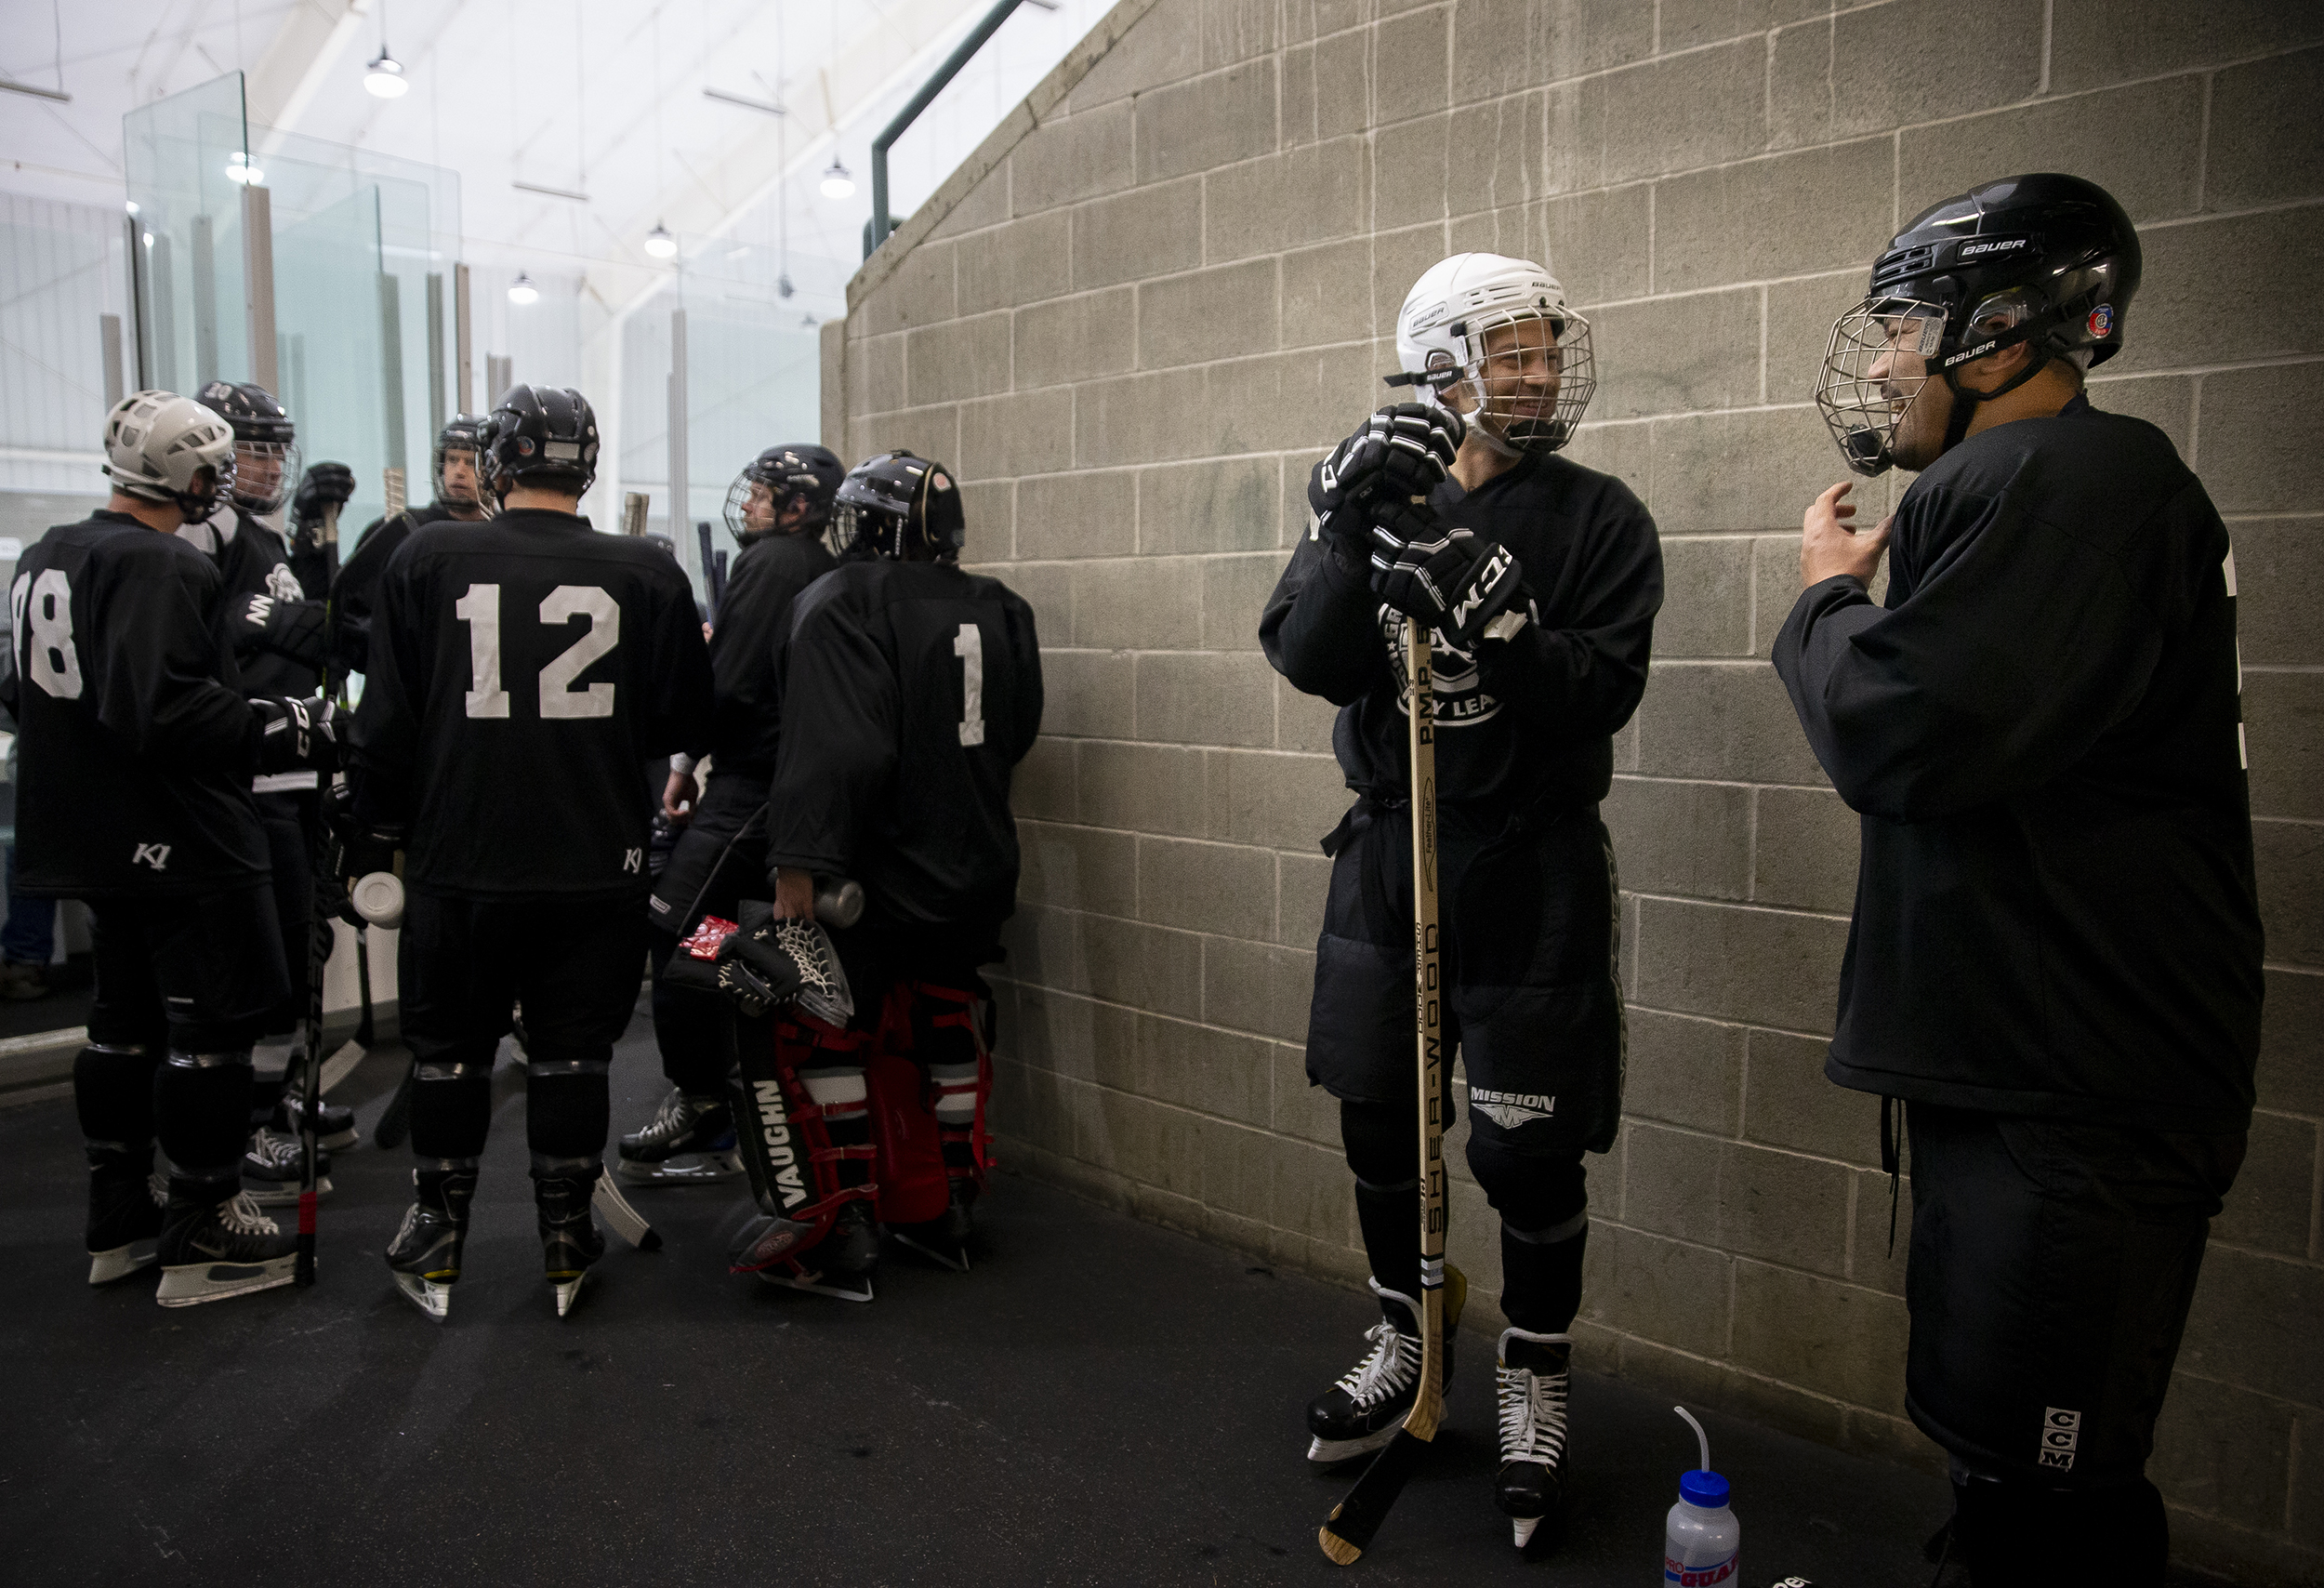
1816, 172, 2141, 474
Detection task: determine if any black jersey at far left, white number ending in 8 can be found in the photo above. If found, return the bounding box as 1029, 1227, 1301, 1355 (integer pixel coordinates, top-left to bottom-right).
7, 511, 268, 897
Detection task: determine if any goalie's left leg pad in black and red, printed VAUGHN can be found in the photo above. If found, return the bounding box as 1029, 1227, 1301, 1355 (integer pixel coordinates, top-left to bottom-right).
728, 1016, 877, 1274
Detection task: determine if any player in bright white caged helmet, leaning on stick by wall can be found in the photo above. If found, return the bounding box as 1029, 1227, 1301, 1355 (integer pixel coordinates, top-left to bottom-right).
1260, 254, 1662, 1548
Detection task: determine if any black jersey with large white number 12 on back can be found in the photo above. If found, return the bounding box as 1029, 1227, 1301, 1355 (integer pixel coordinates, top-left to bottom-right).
356, 509, 711, 900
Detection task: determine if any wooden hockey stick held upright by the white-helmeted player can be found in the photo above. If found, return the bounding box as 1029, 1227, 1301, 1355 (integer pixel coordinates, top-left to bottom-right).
1315, 618, 1446, 1565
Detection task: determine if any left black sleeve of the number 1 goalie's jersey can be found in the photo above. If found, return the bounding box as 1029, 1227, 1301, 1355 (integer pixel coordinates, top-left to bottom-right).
767, 590, 902, 874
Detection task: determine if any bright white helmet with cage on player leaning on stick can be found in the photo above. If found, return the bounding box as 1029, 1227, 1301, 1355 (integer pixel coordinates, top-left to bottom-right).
1390, 254, 1597, 454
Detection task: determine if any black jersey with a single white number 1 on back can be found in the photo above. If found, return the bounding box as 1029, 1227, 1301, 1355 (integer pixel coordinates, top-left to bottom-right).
767, 562, 1041, 925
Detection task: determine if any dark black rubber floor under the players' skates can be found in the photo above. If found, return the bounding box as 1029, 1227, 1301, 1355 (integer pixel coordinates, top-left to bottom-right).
0, 1018, 1950, 1588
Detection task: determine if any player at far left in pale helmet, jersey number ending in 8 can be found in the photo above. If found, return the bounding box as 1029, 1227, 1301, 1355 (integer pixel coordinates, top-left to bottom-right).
0, 390, 337, 1306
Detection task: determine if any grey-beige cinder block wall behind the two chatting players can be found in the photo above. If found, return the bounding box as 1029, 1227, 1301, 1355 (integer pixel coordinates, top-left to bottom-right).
825, 0, 2324, 1581
